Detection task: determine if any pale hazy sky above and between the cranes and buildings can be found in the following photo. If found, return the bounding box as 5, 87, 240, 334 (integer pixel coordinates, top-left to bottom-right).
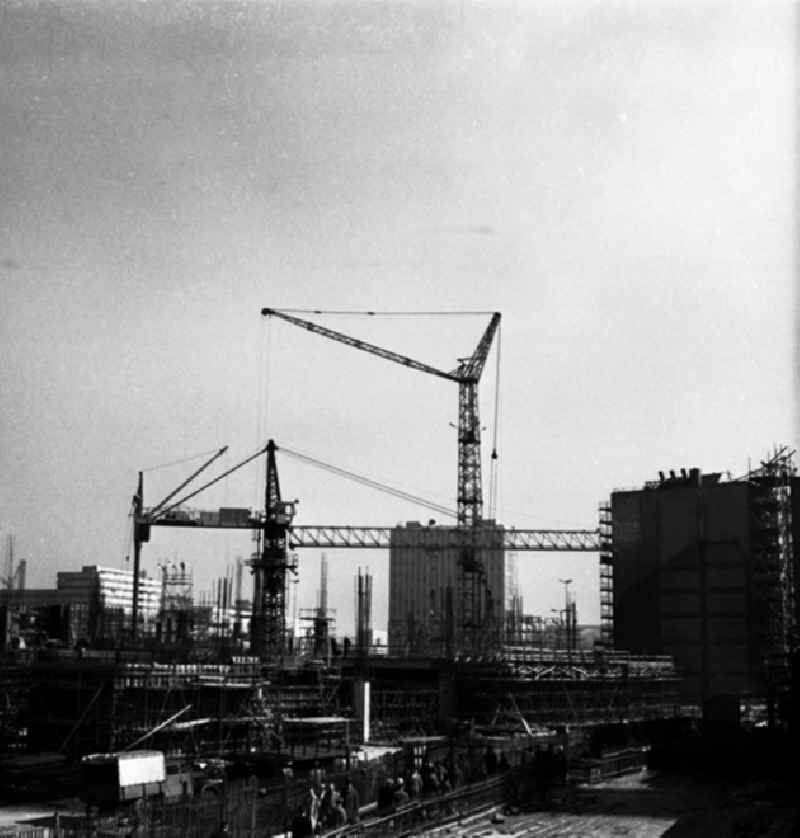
0, 0, 797, 628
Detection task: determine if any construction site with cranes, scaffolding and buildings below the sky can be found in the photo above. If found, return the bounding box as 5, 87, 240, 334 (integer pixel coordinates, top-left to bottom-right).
0, 308, 800, 835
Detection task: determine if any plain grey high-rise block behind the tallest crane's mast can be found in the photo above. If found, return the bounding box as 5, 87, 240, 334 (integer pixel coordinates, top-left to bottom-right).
388, 521, 506, 656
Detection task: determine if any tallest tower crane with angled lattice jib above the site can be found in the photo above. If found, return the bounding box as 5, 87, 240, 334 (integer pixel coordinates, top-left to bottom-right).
261, 308, 500, 637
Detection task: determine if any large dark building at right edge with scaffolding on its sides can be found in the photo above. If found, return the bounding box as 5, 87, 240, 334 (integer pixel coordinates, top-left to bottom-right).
601, 451, 800, 703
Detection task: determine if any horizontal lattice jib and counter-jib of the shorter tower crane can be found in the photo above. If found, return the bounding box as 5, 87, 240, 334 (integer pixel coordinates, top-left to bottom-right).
144, 519, 600, 553
